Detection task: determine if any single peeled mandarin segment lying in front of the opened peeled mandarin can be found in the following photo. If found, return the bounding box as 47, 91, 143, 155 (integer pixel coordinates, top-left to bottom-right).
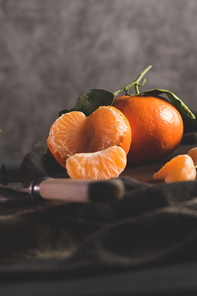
66, 146, 127, 180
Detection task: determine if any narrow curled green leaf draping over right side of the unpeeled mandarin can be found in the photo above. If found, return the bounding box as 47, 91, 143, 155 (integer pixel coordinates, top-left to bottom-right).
140, 89, 197, 126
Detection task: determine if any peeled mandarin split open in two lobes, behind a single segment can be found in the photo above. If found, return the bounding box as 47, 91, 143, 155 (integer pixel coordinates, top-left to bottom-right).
47, 106, 131, 168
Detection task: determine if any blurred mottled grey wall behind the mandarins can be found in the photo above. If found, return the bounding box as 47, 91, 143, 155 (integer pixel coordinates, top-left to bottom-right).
0, 0, 197, 162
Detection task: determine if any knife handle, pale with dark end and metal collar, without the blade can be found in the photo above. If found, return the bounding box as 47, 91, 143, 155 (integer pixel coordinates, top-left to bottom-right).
31, 178, 124, 203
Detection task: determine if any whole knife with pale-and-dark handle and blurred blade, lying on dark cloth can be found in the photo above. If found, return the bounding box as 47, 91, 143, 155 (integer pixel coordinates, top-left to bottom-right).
0, 177, 125, 207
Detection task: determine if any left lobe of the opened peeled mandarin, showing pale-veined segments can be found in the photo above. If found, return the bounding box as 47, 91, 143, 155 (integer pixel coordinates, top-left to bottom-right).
47, 111, 86, 167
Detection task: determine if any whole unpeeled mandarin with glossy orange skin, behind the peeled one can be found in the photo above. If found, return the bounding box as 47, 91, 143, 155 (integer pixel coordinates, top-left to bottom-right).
113, 95, 183, 164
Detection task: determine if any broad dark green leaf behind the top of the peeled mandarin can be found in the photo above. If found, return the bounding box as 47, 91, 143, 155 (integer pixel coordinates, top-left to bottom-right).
58, 89, 114, 116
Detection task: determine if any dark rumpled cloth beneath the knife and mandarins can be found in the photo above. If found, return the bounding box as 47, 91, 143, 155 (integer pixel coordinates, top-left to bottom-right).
0, 120, 197, 280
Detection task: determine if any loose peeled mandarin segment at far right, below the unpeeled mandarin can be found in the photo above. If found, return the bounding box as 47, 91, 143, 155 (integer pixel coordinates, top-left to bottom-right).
153, 154, 196, 183
